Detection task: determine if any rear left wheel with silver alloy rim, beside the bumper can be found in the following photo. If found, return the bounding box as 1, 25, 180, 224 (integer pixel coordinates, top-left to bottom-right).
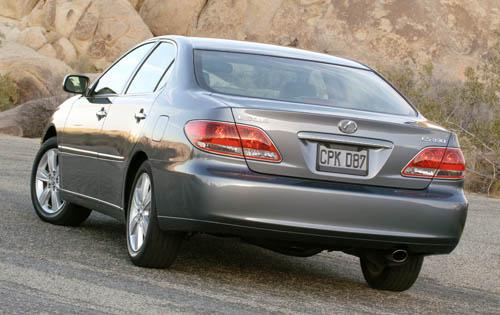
127, 161, 183, 268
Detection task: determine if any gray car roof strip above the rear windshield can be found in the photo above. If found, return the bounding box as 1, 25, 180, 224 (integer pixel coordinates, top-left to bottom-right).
155, 35, 371, 70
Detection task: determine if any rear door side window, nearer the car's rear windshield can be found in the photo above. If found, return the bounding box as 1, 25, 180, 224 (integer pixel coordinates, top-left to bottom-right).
127, 43, 176, 94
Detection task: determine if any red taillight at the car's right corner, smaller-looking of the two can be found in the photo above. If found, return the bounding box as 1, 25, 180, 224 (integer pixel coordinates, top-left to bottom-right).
401, 148, 465, 179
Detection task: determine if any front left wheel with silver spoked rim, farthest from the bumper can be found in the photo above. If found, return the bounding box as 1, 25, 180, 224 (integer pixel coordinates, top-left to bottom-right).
31, 137, 92, 226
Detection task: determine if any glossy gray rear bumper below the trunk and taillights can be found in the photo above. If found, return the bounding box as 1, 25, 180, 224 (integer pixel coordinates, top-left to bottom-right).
153, 160, 468, 254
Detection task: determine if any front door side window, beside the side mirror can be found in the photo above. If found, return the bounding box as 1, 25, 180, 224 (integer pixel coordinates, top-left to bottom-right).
92, 43, 154, 95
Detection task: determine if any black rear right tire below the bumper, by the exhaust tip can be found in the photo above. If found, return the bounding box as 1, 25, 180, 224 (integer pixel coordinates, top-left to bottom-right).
360, 255, 424, 292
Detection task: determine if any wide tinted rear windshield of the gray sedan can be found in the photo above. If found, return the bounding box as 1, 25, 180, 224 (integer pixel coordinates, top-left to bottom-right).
194, 50, 416, 116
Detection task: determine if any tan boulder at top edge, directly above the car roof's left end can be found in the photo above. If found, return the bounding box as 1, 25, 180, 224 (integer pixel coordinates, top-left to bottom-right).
139, 0, 207, 35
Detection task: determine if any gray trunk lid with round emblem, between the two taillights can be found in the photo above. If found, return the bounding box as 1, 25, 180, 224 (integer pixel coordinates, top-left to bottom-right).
217, 96, 450, 189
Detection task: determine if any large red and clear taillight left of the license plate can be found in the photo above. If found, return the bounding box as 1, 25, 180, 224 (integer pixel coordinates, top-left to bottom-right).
184, 120, 281, 162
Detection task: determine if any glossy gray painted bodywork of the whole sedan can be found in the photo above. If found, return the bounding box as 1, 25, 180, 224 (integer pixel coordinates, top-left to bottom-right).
45, 36, 467, 253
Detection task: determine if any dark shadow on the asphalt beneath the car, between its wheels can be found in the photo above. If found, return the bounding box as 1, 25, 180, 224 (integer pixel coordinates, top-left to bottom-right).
81, 214, 367, 291
